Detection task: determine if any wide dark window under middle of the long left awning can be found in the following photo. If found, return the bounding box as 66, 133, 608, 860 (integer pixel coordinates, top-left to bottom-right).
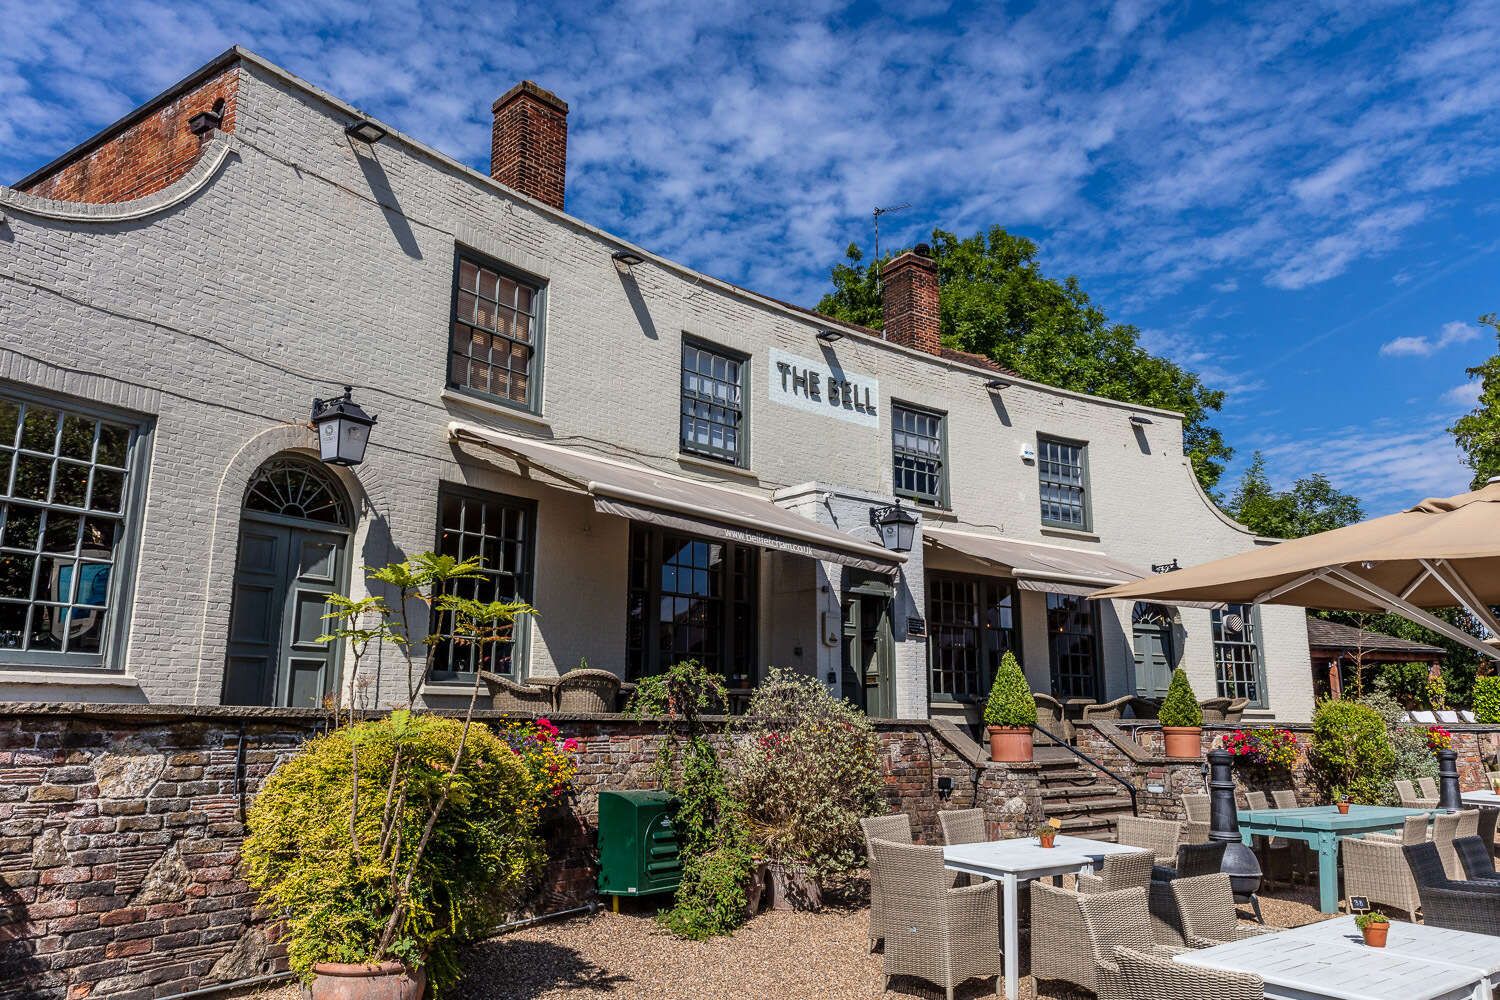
626, 523, 761, 688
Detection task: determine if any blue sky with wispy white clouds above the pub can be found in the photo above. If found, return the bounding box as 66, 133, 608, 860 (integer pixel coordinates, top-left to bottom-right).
0, 0, 1500, 513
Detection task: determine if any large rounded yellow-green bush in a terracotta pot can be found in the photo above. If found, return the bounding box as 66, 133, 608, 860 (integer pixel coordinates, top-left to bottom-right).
242, 712, 545, 990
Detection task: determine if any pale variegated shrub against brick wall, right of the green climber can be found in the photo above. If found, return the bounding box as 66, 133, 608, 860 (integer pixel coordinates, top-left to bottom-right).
731, 667, 885, 888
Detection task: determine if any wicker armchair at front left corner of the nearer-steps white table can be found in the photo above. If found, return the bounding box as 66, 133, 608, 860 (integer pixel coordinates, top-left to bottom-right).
872, 840, 1001, 1000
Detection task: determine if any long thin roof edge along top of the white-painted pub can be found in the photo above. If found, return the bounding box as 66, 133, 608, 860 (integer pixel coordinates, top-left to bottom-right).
15, 45, 1182, 425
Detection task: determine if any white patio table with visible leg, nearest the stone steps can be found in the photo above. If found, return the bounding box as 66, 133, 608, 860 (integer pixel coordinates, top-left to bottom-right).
942, 835, 1140, 1000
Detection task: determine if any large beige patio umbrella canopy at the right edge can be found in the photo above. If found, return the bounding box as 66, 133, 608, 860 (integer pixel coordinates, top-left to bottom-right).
1092, 480, 1500, 660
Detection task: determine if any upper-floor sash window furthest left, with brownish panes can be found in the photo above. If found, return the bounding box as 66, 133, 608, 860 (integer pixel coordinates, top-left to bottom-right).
449, 252, 545, 411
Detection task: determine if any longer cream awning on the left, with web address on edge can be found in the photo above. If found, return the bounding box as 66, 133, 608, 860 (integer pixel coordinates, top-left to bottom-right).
449, 421, 906, 574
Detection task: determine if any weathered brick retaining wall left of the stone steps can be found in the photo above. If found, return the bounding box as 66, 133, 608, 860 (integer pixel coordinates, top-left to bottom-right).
0, 705, 996, 1000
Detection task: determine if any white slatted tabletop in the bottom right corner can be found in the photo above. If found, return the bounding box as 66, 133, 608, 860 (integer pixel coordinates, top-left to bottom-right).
1173, 931, 1488, 1000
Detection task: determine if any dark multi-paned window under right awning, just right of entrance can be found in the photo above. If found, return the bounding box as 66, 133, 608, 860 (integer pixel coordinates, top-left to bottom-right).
927, 573, 1020, 702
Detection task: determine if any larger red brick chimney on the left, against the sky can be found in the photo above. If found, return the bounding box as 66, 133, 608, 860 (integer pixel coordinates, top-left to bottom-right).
489, 79, 567, 210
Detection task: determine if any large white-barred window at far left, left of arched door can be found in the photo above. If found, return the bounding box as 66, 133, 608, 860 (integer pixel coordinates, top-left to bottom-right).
0, 391, 147, 667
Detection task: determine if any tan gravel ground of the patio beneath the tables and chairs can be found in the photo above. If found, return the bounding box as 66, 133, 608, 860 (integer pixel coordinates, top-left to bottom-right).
240, 886, 1344, 1000
